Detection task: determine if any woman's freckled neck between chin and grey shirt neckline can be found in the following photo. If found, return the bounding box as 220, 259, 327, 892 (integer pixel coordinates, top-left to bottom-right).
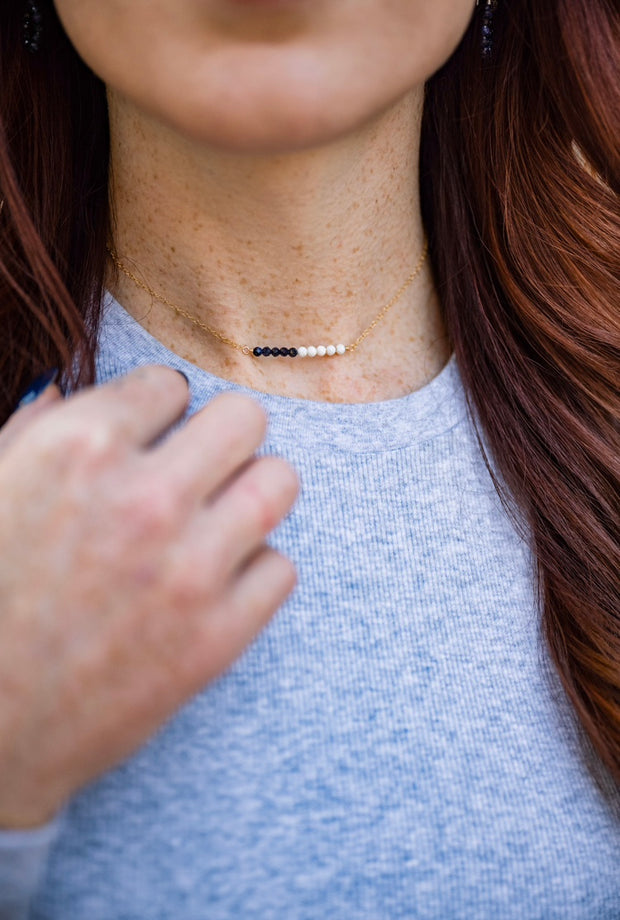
110, 93, 448, 402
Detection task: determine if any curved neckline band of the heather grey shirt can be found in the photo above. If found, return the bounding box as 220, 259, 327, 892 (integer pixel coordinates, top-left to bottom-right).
98, 294, 467, 453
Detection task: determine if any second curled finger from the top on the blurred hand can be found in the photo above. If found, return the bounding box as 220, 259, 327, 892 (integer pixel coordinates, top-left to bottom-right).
148, 393, 267, 501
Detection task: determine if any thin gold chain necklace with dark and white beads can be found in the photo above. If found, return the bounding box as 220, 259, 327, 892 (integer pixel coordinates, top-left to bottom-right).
108, 240, 428, 358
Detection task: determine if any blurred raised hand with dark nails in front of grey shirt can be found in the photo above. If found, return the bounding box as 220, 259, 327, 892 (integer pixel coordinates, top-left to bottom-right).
0, 367, 298, 828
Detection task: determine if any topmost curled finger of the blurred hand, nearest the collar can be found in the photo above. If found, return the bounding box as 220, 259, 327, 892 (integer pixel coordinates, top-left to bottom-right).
42, 366, 189, 447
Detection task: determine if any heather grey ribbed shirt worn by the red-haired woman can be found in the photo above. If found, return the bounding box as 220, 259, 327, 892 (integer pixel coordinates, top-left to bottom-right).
0, 301, 620, 920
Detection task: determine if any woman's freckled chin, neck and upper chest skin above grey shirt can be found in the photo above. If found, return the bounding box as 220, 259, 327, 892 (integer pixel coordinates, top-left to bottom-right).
57, 0, 474, 401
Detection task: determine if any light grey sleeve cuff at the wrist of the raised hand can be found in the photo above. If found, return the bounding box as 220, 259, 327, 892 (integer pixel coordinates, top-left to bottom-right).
0, 813, 63, 920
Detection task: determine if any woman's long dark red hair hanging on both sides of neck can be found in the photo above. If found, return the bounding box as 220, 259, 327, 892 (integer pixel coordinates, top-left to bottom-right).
0, 0, 620, 782
